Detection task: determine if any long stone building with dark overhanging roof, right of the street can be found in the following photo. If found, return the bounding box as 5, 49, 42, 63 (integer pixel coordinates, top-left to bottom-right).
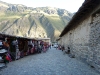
59, 0, 100, 72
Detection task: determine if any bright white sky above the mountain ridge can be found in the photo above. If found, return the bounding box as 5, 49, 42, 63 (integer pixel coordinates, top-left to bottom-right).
0, 0, 85, 13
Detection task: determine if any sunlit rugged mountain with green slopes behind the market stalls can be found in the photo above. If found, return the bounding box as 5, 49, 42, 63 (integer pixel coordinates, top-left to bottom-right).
0, 1, 73, 41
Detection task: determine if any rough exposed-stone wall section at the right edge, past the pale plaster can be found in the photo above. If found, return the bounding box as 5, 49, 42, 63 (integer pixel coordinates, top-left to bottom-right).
87, 13, 100, 71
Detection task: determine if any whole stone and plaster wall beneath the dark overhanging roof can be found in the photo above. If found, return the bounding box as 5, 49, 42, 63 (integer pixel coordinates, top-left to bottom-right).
62, 6, 100, 72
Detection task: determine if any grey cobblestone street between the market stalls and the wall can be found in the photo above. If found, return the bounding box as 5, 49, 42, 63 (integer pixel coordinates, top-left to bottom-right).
0, 48, 100, 75
